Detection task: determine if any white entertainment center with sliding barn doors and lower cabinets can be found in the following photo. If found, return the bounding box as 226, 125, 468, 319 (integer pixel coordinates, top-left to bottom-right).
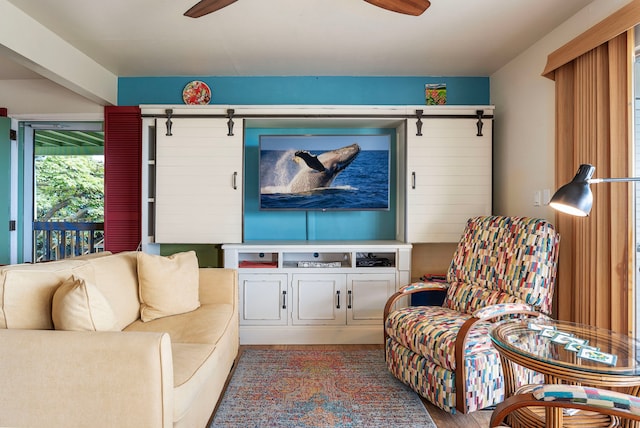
142, 106, 493, 344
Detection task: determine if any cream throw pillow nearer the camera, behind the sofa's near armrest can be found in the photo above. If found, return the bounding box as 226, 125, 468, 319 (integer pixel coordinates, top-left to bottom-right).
51, 276, 118, 331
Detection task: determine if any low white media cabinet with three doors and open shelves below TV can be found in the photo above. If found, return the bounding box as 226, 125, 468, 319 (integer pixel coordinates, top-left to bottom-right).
222, 241, 411, 344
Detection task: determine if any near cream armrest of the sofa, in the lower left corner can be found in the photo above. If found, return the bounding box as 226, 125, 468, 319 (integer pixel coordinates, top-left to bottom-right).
0, 329, 174, 428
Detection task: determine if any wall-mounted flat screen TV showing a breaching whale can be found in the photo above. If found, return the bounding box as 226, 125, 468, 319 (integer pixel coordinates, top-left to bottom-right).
259, 134, 391, 210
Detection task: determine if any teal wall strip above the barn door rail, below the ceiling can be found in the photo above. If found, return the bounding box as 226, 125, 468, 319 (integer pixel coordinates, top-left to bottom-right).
118, 76, 489, 106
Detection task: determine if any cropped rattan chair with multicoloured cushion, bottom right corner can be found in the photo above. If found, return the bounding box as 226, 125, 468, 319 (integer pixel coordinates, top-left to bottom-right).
489, 385, 640, 427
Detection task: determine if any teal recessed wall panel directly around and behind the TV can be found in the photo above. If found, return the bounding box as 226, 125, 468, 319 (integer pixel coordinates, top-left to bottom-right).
244, 128, 397, 241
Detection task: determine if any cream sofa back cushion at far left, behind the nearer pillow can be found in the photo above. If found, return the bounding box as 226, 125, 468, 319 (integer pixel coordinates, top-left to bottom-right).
0, 260, 85, 330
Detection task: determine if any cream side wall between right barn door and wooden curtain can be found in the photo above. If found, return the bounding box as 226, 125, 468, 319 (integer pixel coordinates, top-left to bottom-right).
490, 0, 630, 221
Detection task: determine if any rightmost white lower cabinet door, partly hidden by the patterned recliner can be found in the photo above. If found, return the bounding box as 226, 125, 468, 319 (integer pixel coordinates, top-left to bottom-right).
347, 273, 396, 325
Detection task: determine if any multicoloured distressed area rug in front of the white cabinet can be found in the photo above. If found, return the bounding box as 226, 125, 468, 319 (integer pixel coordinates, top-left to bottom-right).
210, 349, 436, 428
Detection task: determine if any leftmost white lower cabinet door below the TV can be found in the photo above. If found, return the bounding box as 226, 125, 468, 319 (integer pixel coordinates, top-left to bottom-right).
238, 274, 289, 325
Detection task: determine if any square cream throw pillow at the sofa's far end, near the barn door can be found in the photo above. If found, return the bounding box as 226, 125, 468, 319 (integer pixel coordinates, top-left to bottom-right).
138, 251, 200, 322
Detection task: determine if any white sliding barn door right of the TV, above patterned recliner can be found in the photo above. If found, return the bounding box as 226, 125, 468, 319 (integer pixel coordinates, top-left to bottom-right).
406, 118, 492, 243
